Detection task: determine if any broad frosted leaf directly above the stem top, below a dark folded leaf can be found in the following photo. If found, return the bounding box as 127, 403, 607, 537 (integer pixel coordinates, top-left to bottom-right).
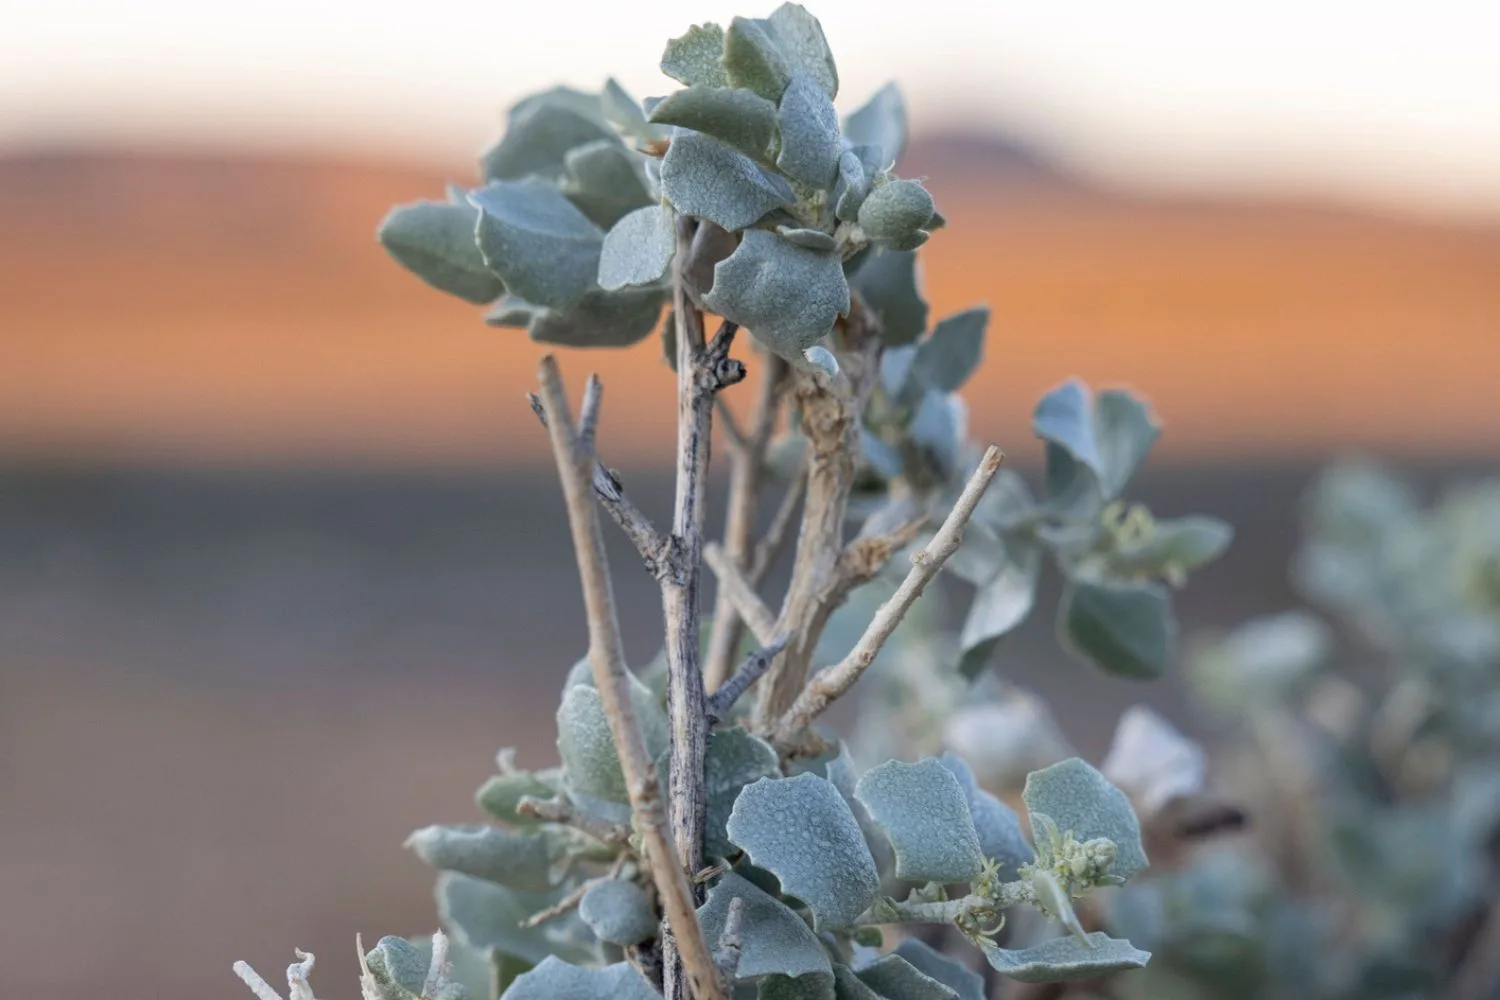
662, 132, 797, 229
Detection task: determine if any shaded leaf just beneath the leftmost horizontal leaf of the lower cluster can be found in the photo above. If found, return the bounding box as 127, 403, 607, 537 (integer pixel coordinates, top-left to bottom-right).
437, 871, 587, 963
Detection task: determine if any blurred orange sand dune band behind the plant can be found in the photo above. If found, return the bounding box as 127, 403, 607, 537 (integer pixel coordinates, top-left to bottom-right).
0, 148, 1500, 463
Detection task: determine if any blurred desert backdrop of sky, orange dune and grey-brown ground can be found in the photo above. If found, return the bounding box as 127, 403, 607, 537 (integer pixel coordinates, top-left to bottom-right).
0, 0, 1500, 1000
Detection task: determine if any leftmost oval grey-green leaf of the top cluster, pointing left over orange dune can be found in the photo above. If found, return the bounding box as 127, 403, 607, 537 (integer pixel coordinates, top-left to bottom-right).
378, 201, 506, 306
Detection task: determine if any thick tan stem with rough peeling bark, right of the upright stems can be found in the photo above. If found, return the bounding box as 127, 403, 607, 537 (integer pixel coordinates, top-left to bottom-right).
755, 305, 881, 732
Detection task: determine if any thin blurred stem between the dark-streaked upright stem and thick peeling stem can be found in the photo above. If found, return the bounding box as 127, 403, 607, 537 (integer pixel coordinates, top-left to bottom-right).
704, 352, 788, 691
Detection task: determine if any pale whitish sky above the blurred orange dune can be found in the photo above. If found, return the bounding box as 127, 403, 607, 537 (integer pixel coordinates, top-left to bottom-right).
0, 0, 1500, 219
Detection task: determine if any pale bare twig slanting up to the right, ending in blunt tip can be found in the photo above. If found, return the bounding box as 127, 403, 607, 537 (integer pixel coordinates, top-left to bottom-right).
774, 445, 1004, 745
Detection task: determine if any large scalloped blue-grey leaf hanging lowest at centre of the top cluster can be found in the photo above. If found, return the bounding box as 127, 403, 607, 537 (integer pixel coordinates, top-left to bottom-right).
704, 229, 849, 360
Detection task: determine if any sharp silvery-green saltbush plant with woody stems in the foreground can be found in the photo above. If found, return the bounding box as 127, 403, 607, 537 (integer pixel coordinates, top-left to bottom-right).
237, 3, 1229, 1000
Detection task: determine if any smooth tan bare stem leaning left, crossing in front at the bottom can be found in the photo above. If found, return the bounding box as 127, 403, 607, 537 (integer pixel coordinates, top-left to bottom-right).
539, 355, 723, 1000
